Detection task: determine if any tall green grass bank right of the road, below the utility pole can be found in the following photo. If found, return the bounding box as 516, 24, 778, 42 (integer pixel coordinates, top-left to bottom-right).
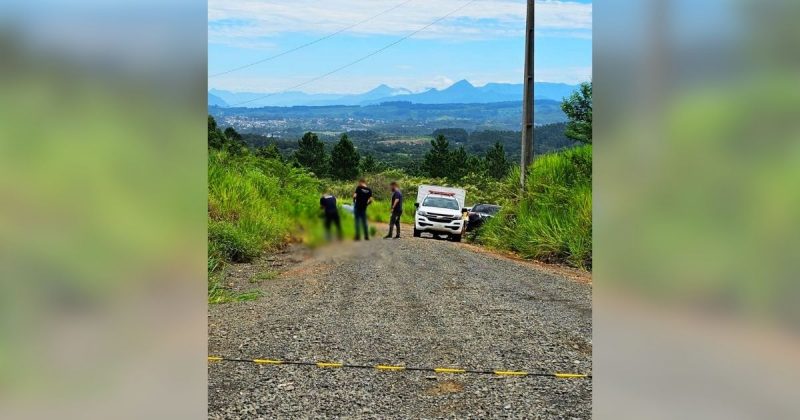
478, 145, 592, 269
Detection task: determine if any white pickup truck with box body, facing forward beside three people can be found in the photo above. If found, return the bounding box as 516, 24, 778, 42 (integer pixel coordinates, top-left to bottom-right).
414, 185, 467, 242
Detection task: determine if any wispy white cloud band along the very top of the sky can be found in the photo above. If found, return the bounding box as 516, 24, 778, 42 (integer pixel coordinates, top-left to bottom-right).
208, 0, 592, 44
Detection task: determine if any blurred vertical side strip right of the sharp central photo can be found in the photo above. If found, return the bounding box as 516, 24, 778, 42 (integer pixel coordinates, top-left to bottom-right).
593, 0, 800, 419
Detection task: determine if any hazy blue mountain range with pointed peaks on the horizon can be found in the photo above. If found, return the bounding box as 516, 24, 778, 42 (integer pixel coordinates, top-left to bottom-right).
208, 80, 577, 108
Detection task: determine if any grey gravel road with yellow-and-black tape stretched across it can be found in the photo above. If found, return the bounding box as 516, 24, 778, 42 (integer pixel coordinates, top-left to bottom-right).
208, 228, 592, 419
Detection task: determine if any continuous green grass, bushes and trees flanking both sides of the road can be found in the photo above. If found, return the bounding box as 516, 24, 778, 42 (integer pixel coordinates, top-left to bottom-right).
208, 80, 592, 302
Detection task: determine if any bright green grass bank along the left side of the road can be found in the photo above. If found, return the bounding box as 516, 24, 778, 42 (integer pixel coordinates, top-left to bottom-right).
208, 150, 320, 303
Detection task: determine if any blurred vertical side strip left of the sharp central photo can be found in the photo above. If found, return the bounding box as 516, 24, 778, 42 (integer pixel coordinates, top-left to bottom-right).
0, 0, 206, 419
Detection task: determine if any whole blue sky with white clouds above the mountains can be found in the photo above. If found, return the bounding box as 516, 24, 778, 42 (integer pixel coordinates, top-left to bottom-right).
208, 0, 592, 93
